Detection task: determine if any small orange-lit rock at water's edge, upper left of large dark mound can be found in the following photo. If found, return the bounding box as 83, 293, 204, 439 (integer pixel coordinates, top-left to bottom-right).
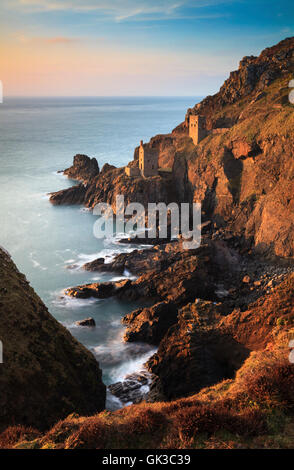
122, 302, 178, 344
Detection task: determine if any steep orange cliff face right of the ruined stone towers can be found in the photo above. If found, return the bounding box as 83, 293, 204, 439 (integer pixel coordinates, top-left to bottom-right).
179, 38, 294, 257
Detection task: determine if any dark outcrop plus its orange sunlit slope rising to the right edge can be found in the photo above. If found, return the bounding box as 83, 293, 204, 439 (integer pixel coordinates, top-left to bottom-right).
147, 273, 294, 400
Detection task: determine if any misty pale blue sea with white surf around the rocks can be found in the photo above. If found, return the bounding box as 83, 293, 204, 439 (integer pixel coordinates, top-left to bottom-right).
0, 97, 199, 404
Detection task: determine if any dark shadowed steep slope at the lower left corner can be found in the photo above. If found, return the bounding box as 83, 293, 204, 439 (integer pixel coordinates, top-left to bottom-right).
0, 249, 106, 429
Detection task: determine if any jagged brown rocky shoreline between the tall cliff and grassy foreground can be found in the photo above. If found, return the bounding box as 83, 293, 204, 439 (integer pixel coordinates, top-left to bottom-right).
66, 235, 294, 404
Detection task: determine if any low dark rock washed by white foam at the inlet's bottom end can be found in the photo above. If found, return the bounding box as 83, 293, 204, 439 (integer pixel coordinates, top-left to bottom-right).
108, 370, 152, 404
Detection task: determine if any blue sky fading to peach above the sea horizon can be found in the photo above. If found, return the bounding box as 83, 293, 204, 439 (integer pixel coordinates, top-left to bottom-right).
0, 0, 294, 96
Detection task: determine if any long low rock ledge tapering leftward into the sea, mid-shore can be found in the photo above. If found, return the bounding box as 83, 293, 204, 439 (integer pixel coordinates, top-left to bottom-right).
66, 244, 219, 305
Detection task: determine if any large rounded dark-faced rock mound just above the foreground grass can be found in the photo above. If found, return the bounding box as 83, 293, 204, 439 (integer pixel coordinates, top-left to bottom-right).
147, 300, 248, 400
